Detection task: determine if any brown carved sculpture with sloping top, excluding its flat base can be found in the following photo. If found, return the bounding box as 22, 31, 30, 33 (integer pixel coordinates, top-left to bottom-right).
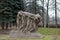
17, 11, 41, 33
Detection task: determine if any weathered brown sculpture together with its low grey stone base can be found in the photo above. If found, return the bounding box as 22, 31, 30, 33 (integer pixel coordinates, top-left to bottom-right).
10, 11, 41, 37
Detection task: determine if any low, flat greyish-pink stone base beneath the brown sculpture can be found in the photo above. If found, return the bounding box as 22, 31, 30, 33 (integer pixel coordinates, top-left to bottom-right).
10, 31, 44, 38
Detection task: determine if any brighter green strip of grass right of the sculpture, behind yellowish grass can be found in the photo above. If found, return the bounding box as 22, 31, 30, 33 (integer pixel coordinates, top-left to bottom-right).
38, 28, 60, 35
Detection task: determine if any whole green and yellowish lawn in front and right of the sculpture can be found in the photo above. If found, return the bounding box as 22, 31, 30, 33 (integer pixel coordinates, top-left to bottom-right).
0, 28, 60, 40
